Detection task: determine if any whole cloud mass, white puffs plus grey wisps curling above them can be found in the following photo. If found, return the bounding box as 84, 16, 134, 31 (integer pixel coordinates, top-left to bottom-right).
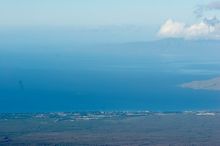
158, 1, 220, 40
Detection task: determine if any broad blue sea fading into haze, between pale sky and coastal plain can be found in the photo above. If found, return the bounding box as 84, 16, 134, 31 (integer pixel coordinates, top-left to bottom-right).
0, 39, 220, 112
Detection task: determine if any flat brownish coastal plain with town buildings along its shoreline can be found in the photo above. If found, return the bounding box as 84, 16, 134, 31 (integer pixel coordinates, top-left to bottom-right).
0, 111, 220, 146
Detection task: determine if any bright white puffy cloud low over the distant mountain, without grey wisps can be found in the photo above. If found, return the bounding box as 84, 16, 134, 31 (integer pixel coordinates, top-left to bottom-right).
158, 19, 220, 39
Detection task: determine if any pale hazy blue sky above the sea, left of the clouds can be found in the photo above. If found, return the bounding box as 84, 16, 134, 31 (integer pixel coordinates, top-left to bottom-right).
0, 0, 219, 41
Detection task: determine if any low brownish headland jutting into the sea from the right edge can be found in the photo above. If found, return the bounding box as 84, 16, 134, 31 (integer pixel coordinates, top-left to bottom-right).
181, 77, 220, 91
